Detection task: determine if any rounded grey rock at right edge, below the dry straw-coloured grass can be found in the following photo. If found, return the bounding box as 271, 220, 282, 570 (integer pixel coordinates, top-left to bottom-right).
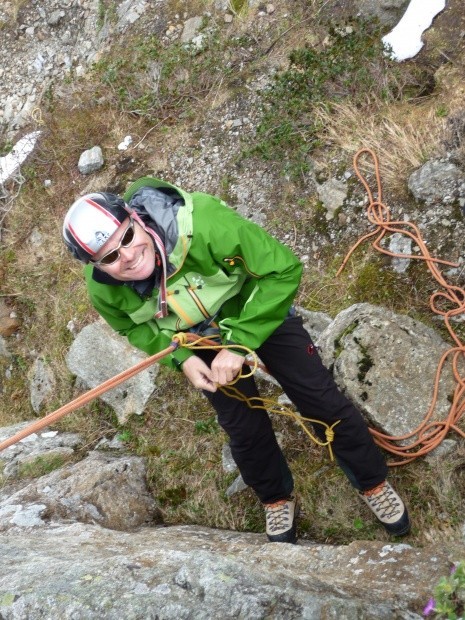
408, 160, 465, 204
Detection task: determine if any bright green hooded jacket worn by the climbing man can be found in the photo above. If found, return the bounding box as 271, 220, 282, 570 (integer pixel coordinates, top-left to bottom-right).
85, 177, 302, 367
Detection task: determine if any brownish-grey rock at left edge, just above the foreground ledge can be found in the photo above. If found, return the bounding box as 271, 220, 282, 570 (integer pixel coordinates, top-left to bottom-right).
0, 452, 161, 531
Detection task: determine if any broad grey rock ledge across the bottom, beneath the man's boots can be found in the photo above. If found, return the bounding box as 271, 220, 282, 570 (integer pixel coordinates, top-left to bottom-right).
0, 524, 456, 620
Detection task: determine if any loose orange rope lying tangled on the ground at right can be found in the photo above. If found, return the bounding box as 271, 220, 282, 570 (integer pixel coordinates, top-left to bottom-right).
337, 148, 465, 466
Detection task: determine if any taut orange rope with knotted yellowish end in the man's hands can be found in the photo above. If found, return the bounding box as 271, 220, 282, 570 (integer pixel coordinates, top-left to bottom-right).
0, 332, 339, 460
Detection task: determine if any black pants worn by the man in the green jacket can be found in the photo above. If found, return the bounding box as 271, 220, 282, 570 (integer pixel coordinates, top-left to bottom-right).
196, 316, 387, 503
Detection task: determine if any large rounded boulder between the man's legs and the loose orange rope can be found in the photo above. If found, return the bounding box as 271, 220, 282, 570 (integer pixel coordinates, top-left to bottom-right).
318, 304, 454, 436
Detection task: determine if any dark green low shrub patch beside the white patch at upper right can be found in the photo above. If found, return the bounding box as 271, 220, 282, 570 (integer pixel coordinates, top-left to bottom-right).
250, 21, 399, 172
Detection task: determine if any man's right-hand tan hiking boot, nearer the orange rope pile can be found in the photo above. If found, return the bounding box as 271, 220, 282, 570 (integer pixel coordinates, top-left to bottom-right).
360, 480, 410, 536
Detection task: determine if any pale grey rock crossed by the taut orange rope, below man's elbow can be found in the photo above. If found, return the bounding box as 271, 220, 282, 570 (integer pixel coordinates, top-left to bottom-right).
66, 321, 158, 423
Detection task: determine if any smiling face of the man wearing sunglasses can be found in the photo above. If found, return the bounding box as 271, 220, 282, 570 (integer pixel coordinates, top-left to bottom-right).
93, 217, 155, 281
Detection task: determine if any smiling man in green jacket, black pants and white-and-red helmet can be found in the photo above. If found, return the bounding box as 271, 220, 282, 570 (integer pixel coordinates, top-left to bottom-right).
63, 177, 410, 543
